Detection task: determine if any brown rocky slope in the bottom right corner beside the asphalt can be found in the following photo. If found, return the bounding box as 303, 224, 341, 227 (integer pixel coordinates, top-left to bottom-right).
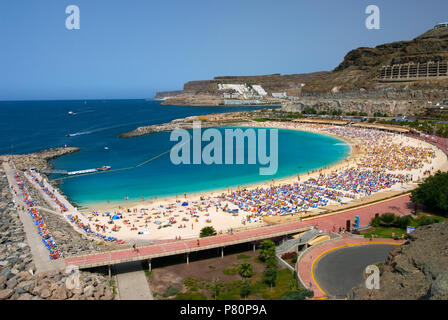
349, 221, 448, 300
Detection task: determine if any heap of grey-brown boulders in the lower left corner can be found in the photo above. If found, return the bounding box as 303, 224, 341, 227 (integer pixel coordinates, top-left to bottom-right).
0, 166, 115, 300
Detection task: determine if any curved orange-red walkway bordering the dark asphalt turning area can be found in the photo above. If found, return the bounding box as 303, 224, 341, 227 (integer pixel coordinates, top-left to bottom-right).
296, 236, 405, 299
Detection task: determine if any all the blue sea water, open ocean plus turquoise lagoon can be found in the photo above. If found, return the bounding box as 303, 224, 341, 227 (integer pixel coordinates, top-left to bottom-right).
0, 100, 350, 205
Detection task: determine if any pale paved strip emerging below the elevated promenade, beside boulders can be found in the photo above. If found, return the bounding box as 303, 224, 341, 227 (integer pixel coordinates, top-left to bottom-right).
114, 261, 154, 300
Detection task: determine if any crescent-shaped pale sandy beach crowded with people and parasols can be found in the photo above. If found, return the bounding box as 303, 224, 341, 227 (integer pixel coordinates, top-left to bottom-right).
39, 122, 447, 242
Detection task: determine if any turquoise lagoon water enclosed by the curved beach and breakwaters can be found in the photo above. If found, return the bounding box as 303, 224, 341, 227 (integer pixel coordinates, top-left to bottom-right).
53, 128, 349, 205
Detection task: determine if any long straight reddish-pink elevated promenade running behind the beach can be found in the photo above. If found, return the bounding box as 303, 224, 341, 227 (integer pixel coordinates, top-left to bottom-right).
65, 195, 413, 268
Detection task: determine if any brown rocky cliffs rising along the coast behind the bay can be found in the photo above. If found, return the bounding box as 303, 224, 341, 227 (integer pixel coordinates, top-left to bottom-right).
157, 28, 448, 115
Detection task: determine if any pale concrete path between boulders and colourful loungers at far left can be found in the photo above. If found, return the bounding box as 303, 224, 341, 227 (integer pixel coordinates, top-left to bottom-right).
3, 162, 65, 272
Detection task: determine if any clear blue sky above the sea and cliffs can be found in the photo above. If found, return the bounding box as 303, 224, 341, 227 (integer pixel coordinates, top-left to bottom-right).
0, 0, 448, 100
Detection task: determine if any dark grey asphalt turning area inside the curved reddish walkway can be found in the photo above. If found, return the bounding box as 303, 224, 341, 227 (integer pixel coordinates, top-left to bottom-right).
314, 244, 395, 298
